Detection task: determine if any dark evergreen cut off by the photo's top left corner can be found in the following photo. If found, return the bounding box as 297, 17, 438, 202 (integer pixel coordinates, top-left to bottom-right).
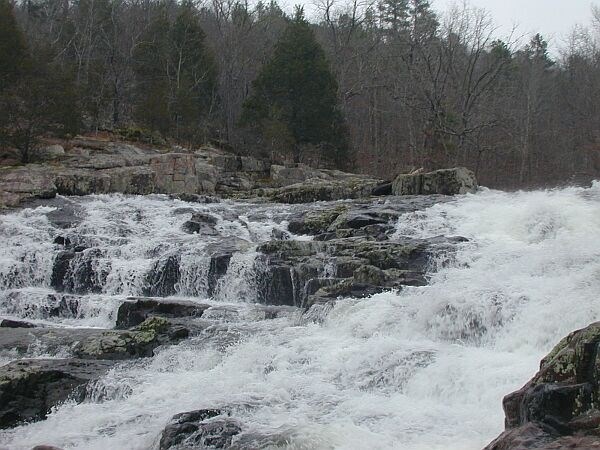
0, 0, 27, 92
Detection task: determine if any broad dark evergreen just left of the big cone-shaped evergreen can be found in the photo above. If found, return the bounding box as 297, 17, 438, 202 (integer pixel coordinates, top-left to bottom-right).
134, 3, 217, 142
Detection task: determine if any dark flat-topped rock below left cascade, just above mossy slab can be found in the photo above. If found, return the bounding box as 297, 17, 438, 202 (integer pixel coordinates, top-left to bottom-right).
116, 297, 209, 329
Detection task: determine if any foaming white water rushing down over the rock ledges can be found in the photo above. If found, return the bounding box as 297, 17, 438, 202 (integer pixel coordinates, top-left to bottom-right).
0, 184, 600, 450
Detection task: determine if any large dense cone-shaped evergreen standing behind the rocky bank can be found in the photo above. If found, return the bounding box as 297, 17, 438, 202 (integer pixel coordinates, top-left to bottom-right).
242, 7, 347, 163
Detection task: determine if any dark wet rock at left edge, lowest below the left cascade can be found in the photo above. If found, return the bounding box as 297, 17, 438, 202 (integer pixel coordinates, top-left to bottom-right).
0, 359, 113, 428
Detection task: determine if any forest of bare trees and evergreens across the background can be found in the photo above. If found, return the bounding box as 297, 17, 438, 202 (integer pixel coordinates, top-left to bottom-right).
0, 0, 600, 188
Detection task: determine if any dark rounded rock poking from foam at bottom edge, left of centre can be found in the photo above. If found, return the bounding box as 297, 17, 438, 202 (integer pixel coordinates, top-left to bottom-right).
159, 409, 242, 450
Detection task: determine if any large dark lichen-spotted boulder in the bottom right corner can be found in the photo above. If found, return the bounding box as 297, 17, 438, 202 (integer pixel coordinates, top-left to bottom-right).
486, 322, 600, 450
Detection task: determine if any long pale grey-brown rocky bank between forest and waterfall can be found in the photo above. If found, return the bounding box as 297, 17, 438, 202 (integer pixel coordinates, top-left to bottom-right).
0, 137, 477, 208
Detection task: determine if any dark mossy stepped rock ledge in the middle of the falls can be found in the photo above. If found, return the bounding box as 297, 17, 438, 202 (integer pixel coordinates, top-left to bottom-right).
253, 197, 464, 307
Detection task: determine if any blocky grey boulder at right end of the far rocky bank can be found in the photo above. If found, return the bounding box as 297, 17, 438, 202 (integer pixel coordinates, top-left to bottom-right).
392, 167, 477, 195
